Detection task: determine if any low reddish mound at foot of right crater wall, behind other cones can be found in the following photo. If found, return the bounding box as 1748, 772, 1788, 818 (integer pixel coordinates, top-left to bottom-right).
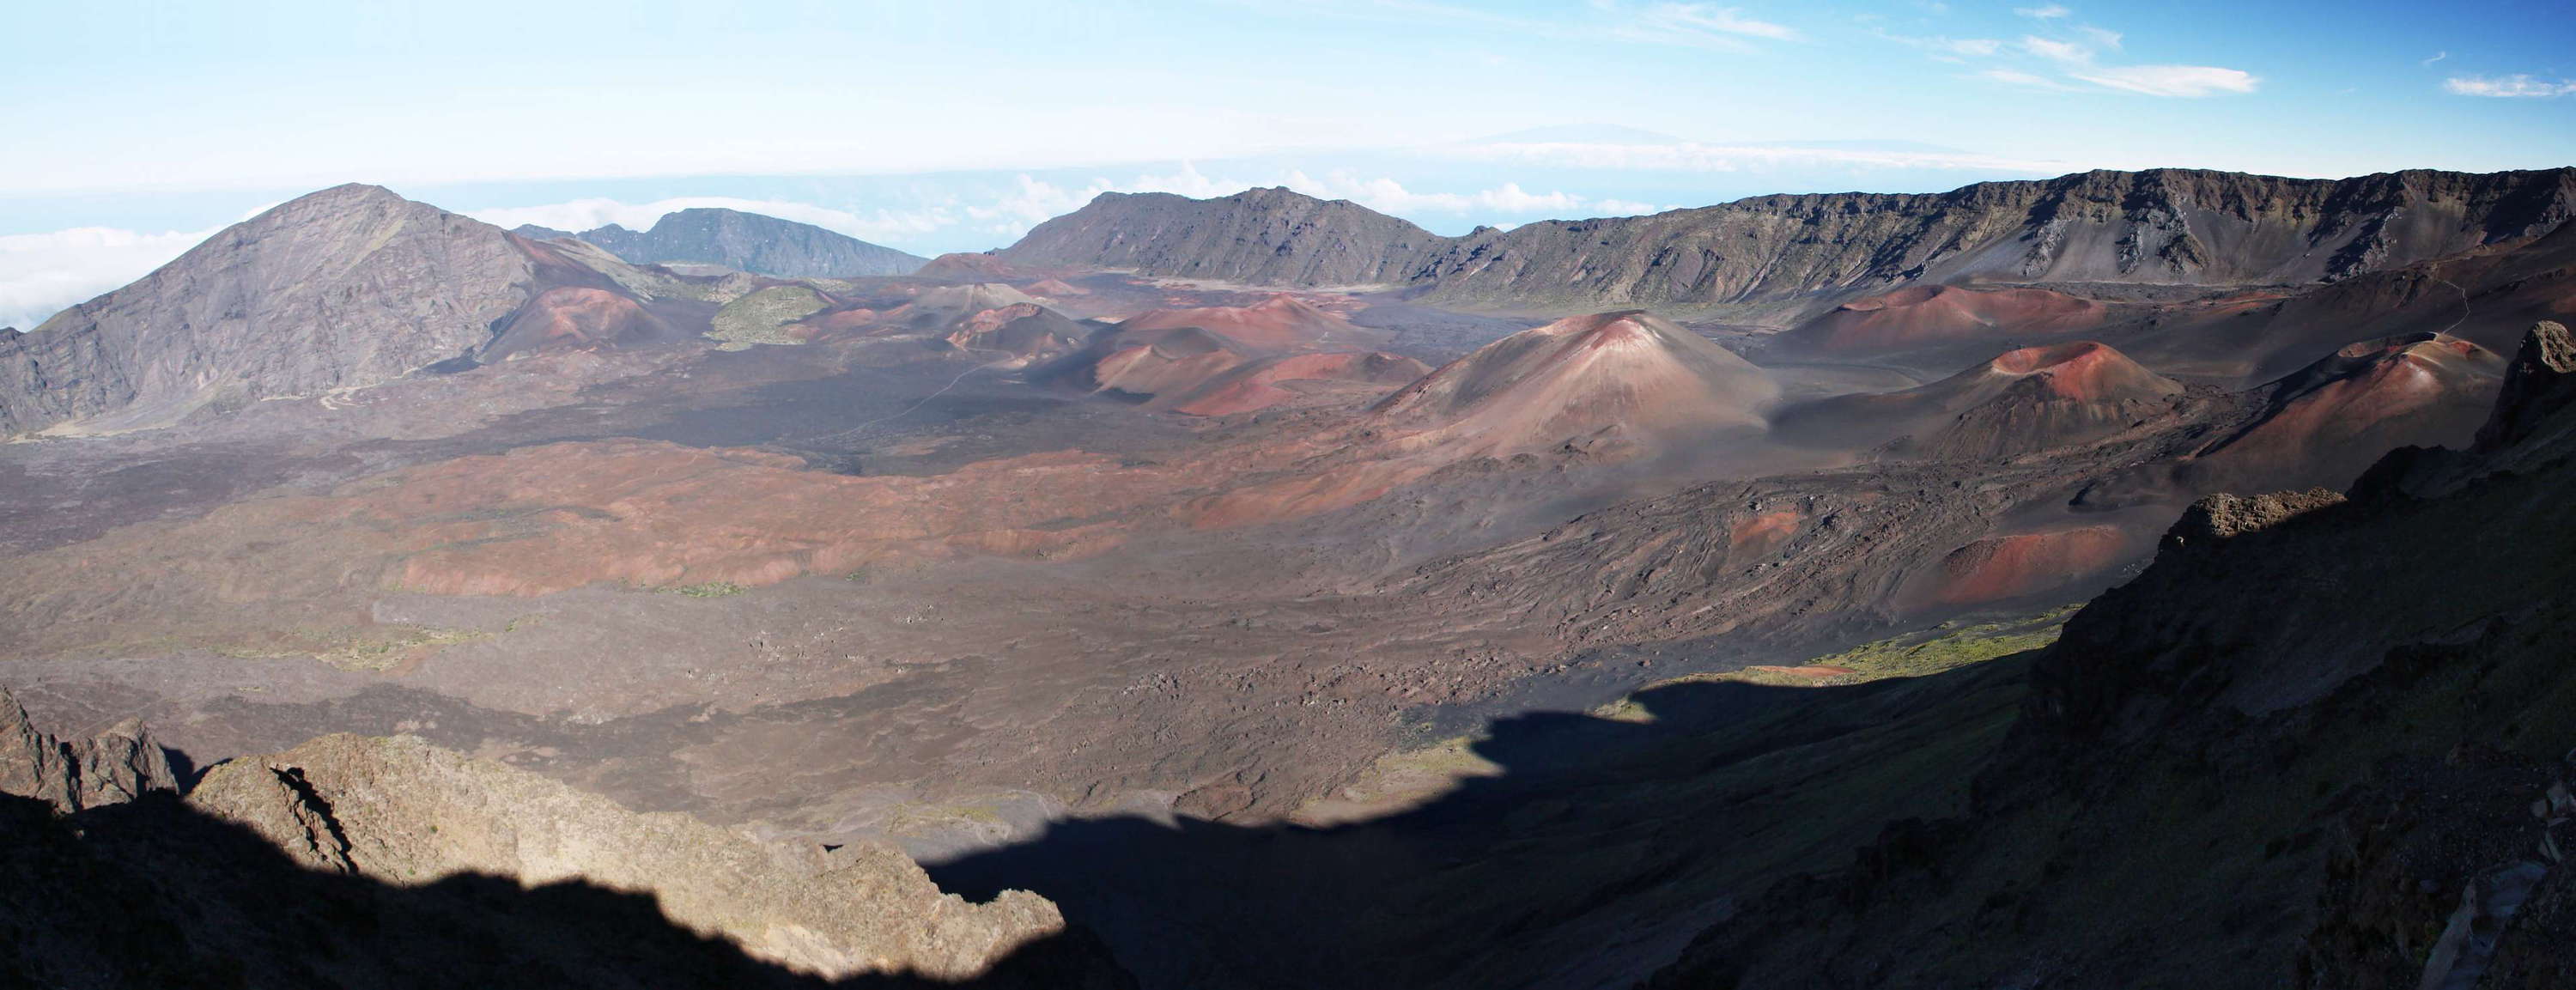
1788, 286, 2110, 353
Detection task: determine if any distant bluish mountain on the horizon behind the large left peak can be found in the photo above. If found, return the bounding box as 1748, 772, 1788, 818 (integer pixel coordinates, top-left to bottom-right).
515, 206, 930, 278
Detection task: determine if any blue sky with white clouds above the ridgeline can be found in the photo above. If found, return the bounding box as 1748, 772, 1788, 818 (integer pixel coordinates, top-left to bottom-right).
0, 0, 2576, 327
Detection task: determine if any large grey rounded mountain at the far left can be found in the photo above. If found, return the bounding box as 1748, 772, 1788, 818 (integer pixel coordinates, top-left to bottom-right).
0, 185, 533, 435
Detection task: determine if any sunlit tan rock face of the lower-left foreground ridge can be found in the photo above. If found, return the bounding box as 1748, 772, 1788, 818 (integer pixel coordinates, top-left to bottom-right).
188, 735, 1064, 980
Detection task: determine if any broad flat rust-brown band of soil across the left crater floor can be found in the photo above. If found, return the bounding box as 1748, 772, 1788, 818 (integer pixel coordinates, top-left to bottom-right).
0, 440, 1206, 634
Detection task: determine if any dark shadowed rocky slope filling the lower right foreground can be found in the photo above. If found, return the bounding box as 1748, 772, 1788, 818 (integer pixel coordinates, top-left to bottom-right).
1656, 322, 2576, 987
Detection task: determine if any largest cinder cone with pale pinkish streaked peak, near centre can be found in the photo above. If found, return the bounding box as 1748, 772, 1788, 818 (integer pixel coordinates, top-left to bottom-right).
1376, 312, 1780, 453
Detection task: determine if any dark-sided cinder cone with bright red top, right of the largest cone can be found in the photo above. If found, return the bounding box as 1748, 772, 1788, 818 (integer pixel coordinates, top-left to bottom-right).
1772, 340, 2182, 456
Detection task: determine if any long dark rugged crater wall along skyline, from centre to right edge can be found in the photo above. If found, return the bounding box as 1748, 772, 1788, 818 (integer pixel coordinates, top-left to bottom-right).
1002, 167, 2576, 307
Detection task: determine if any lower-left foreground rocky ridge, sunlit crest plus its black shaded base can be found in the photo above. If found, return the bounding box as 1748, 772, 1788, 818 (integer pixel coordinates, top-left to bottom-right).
0, 691, 1123, 987
